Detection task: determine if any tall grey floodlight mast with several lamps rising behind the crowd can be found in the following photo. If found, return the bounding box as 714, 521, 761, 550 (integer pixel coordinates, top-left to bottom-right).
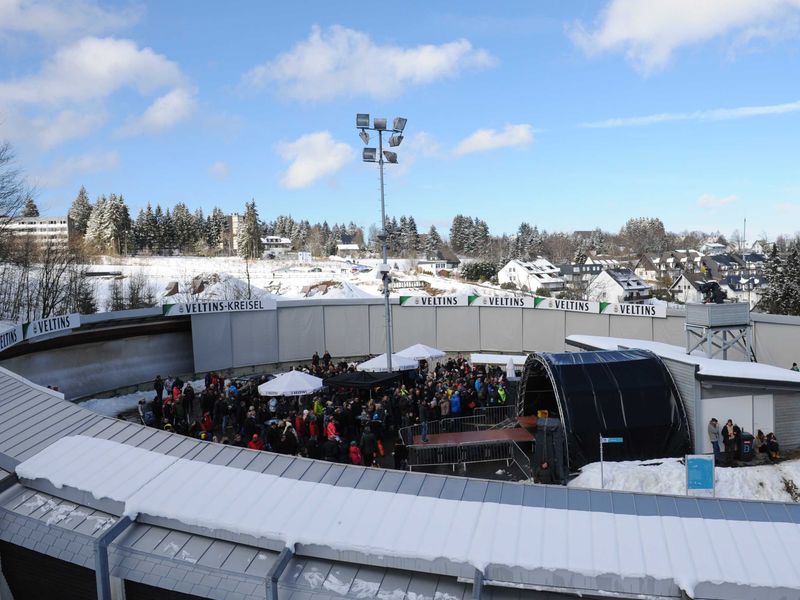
356, 113, 407, 373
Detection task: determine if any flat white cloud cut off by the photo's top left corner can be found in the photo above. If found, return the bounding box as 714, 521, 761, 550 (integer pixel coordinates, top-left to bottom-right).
0, 0, 142, 38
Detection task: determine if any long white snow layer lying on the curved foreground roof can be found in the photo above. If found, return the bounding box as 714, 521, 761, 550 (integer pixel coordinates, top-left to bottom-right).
17, 436, 800, 597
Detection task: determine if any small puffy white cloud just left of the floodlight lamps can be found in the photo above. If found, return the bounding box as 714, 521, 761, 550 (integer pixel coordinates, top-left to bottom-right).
277, 131, 355, 189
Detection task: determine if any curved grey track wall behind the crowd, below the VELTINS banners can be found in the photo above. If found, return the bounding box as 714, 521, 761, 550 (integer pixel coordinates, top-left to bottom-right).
0, 298, 800, 398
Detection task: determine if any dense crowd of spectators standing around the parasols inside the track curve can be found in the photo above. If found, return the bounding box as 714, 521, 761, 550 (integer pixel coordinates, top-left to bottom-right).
139, 352, 510, 469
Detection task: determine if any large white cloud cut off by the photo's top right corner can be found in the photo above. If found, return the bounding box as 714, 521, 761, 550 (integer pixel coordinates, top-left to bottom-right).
568, 0, 800, 73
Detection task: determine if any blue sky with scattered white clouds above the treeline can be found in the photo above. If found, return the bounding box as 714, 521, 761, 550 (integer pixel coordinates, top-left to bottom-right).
0, 0, 800, 239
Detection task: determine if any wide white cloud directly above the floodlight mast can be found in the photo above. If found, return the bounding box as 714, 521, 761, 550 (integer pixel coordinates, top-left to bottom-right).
244, 25, 496, 100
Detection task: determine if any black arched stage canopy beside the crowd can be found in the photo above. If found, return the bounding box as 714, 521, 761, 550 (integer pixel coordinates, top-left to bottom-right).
519, 350, 691, 481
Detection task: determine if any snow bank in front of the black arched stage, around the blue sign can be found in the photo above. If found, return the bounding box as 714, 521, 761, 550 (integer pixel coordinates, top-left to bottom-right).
569, 458, 800, 502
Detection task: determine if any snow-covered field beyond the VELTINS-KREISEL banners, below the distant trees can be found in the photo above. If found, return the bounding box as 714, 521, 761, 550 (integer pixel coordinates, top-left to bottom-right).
84, 256, 513, 311
